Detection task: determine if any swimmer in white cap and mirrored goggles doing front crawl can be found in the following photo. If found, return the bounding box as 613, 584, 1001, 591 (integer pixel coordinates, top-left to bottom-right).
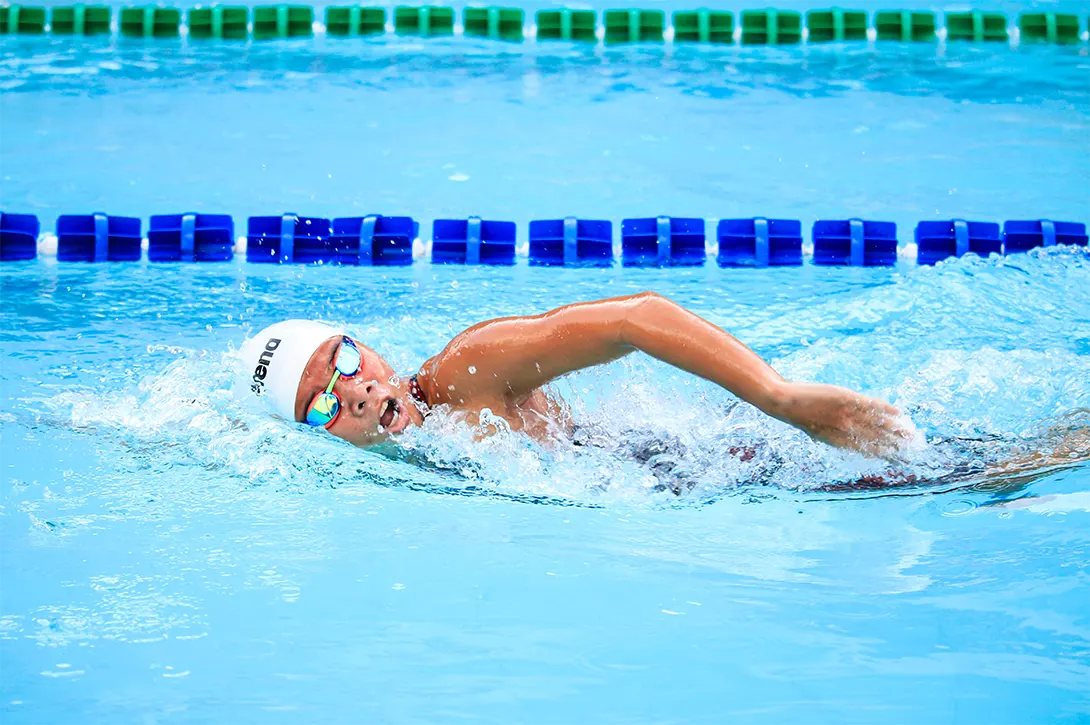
241, 292, 916, 459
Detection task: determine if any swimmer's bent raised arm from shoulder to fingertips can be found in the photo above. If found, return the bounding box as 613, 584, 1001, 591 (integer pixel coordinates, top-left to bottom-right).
421, 292, 909, 456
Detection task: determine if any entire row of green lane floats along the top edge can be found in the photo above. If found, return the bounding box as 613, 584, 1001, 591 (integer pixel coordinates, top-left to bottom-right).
0, 0, 1082, 45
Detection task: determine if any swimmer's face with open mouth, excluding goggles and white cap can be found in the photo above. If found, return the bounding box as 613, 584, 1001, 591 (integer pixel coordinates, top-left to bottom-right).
295, 335, 424, 446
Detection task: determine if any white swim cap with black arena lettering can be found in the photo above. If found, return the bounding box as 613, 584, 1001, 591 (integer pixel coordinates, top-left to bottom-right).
240, 319, 344, 422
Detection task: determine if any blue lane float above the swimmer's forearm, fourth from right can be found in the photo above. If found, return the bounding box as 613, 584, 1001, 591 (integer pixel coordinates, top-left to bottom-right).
715, 217, 802, 267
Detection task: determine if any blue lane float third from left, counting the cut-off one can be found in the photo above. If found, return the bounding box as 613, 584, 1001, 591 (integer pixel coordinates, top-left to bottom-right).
147, 214, 234, 262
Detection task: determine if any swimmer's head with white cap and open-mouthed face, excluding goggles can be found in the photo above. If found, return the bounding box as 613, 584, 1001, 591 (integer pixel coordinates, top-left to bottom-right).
241, 319, 423, 446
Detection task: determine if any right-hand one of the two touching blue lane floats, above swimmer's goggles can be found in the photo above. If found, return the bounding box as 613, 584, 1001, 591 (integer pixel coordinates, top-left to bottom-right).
322, 214, 419, 267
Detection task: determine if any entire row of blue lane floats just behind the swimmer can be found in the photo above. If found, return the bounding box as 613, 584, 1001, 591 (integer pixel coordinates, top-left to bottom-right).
8, 213, 1088, 267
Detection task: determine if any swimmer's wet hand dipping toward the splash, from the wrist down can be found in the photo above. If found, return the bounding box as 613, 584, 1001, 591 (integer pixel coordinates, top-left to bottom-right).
767, 382, 916, 460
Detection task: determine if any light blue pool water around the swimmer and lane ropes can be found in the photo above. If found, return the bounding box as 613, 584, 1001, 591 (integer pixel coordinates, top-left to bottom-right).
0, 14, 1090, 724
